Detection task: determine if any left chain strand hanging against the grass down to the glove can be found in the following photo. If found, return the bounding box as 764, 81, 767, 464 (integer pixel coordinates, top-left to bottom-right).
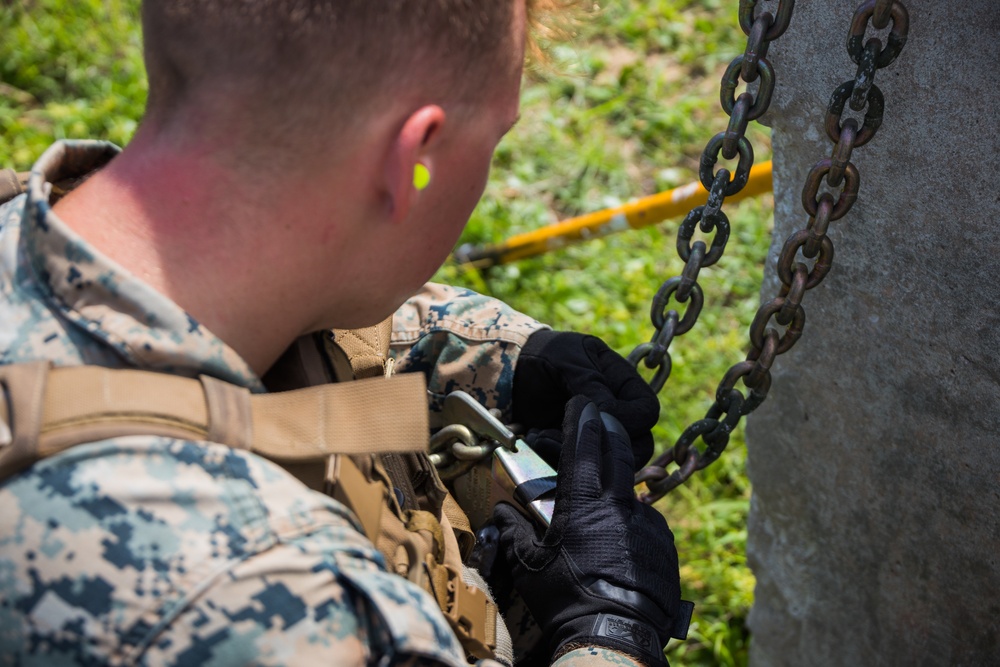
628, 0, 795, 393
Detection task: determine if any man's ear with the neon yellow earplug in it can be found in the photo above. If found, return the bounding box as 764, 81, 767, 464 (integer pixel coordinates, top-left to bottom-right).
384, 105, 445, 222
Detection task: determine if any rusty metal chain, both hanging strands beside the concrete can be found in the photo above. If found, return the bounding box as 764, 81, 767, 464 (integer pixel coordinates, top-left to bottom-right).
629, 0, 909, 503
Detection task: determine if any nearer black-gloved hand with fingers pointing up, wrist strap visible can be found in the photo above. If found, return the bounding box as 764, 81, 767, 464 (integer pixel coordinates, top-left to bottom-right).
494, 396, 681, 665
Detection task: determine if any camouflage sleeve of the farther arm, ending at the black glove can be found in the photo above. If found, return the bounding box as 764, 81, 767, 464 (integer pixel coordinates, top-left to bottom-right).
390, 283, 549, 420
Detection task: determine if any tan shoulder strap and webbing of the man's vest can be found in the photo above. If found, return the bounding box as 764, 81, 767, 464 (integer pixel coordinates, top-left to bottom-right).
0, 362, 510, 664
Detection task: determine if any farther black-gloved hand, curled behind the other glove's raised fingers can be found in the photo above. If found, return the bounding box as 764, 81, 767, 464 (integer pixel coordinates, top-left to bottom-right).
513, 330, 660, 470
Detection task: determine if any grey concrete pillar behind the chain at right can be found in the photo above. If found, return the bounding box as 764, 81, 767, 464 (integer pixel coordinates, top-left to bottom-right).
748, 0, 1000, 667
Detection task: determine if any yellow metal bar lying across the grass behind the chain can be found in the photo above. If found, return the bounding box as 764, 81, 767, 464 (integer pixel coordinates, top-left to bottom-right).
455, 161, 772, 268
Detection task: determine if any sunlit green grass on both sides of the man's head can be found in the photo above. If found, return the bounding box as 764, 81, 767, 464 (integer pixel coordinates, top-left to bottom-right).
0, 0, 771, 665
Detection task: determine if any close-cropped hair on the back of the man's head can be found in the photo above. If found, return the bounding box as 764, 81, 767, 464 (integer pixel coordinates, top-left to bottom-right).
143, 0, 536, 154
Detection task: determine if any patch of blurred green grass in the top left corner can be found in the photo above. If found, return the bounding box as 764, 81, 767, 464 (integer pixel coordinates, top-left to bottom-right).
0, 0, 146, 169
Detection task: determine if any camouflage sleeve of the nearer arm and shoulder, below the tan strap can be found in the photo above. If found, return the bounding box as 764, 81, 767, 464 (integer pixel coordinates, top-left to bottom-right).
0, 436, 466, 667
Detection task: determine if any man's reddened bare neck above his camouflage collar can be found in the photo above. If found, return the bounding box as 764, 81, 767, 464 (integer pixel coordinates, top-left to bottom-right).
55, 132, 362, 374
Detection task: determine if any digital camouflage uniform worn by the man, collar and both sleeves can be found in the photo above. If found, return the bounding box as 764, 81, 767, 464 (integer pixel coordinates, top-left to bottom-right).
0, 142, 541, 665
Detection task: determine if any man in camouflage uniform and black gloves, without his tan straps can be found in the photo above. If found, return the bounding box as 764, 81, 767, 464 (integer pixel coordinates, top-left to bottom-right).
0, 0, 679, 665
